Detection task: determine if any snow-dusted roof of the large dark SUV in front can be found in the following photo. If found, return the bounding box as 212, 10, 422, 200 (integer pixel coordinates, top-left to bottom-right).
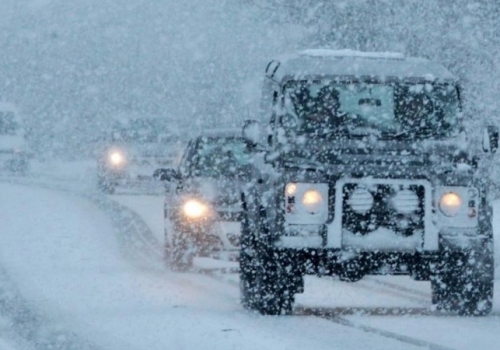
266, 49, 457, 83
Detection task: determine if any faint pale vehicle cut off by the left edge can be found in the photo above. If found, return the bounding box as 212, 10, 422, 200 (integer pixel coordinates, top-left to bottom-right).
0, 103, 29, 175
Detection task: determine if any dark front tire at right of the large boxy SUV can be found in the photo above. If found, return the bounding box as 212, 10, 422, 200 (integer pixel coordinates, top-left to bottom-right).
431, 248, 494, 316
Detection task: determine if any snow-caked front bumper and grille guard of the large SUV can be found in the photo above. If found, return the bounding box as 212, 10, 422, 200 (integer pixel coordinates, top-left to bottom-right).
276, 178, 490, 254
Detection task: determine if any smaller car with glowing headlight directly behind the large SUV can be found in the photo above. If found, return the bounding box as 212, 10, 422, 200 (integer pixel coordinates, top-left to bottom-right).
155, 131, 258, 271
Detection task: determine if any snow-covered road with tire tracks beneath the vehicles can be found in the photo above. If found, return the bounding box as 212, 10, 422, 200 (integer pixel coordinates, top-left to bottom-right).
0, 164, 500, 350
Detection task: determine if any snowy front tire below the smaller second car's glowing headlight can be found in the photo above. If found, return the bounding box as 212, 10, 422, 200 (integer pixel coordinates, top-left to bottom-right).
164, 226, 196, 272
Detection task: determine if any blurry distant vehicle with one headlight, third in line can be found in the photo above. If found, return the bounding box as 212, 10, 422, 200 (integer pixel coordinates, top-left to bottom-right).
97, 118, 180, 194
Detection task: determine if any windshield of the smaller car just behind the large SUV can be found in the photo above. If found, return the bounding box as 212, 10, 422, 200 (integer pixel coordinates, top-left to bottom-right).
188, 137, 251, 177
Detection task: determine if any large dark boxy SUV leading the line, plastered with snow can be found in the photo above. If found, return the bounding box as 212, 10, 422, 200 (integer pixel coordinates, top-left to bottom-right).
240, 50, 498, 315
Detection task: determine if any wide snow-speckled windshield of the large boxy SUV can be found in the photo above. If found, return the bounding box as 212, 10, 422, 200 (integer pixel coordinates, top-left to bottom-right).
283, 81, 459, 138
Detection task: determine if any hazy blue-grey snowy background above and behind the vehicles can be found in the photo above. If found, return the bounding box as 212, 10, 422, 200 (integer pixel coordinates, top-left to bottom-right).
0, 0, 500, 157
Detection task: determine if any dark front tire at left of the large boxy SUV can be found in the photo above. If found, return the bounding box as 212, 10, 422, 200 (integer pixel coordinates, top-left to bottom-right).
240, 205, 294, 315
